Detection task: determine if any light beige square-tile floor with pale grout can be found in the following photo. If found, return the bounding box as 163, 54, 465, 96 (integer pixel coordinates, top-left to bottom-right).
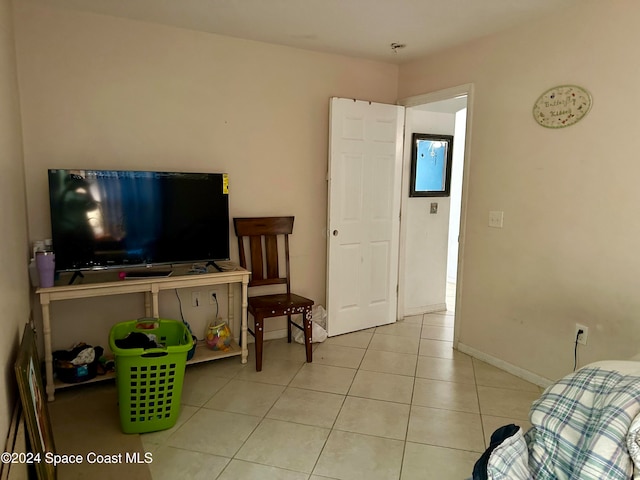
142, 284, 541, 480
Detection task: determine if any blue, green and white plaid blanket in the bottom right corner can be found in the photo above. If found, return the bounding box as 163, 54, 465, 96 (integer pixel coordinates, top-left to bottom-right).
488, 367, 640, 480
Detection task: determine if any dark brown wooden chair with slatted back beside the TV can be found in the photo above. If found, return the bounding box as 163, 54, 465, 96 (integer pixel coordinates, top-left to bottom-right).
233, 217, 313, 372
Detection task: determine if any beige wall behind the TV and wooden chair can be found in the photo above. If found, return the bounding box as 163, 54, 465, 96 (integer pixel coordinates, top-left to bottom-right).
16, 2, 398, 348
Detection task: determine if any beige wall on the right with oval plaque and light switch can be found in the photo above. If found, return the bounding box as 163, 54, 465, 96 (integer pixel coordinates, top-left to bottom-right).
399, 0, 640, 379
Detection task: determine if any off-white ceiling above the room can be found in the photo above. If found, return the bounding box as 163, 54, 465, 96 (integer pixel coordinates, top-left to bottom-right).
31, 0, 582, 64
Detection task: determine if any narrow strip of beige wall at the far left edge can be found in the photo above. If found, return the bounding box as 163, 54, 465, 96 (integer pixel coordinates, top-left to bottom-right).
0, 0, 30, 439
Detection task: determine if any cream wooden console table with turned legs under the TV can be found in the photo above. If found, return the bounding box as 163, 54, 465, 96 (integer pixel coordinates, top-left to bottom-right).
36, 267, 250, 402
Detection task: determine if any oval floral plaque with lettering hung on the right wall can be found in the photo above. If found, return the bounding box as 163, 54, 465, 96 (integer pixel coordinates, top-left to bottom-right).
533, 85, 591, 128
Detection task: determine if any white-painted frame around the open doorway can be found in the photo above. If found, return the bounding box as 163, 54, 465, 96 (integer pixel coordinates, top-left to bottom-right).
397, 83, 474, 348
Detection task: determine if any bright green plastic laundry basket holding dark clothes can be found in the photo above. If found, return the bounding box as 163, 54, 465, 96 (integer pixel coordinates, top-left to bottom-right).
109, 319, 193, 433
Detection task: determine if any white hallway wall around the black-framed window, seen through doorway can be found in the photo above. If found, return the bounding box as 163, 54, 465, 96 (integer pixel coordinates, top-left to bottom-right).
401, 107, 455, 316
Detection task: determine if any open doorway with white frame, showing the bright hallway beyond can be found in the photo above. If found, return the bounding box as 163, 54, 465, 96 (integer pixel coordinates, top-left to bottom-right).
398, 85, 473, 346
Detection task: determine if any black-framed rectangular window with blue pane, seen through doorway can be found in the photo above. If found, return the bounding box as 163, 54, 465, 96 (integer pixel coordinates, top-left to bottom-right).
409, 133, 453, 197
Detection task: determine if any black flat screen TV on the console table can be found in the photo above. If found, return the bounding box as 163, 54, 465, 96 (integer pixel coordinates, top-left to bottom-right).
49, 169, 229, 271
